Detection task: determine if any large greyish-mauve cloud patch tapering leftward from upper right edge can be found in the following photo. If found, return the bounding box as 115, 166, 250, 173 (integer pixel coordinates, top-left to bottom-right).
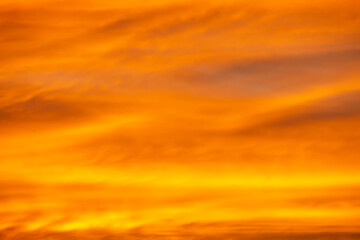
171, 49, 360, 97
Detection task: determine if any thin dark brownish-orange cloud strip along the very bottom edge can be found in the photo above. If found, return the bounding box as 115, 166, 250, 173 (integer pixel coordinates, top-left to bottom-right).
0, 228, 360, 240
